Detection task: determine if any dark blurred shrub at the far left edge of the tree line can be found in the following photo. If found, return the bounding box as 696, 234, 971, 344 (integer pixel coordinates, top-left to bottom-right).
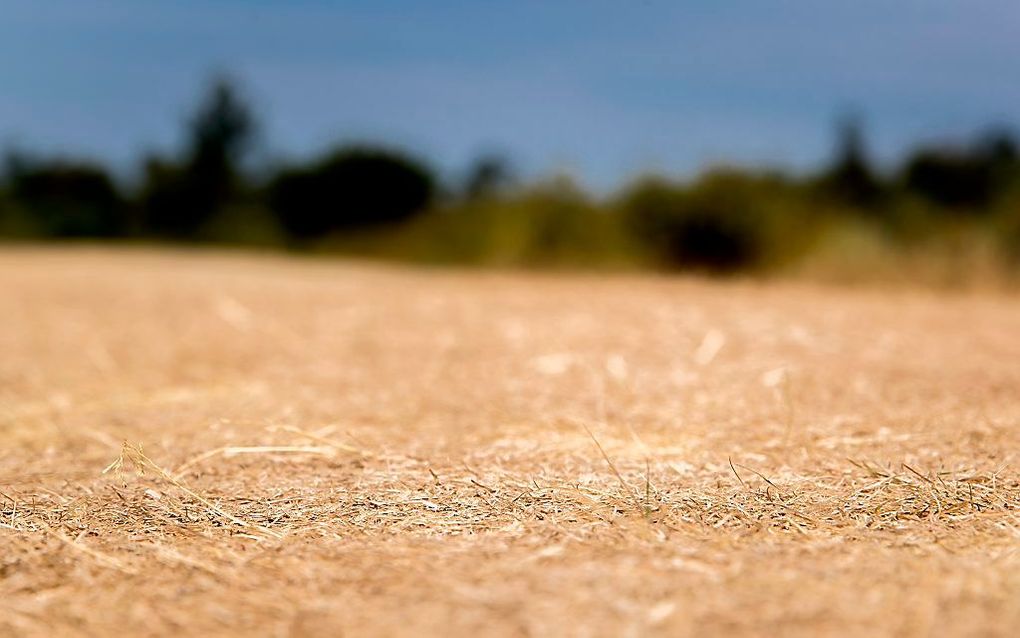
7, 160, 130, 237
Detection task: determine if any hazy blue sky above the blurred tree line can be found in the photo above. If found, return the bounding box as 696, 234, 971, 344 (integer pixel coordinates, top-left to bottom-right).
0, 0, 1020, 188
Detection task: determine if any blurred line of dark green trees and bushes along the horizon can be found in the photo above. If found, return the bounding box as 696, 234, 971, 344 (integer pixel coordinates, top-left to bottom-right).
0, 80, 1020, 274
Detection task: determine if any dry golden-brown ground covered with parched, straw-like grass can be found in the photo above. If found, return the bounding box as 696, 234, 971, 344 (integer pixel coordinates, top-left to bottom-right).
0, 248, 1020, 637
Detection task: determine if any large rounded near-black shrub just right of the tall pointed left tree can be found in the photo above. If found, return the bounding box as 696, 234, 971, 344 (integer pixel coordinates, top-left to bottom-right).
268, 148, 436, 239
